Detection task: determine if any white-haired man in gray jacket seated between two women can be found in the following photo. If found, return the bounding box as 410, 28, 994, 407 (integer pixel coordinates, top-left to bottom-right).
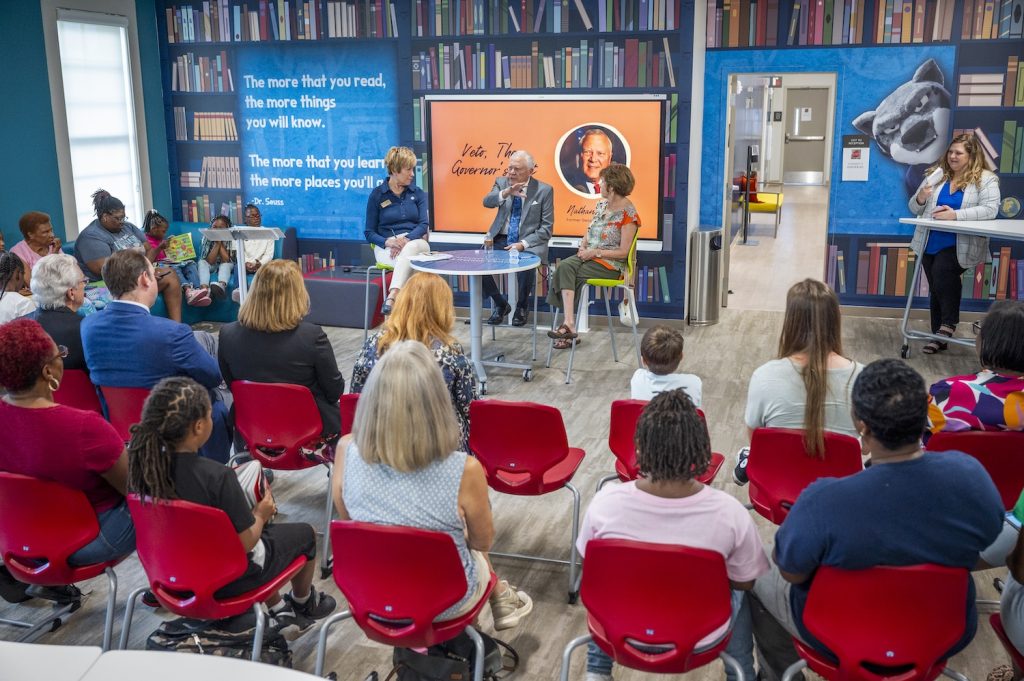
483, 151, 555, 327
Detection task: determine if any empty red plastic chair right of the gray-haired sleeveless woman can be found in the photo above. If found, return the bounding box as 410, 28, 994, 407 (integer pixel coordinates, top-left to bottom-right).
469, 399, 585, 603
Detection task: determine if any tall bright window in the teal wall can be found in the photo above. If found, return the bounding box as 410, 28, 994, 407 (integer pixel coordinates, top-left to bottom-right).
56, 9, 143, 236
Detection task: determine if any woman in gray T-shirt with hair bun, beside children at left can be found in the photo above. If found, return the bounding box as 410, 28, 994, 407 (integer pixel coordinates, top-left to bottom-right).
75, 189, 181, 322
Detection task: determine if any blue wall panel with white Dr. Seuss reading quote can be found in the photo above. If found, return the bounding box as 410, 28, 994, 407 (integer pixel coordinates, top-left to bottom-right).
234, 41, 399, 241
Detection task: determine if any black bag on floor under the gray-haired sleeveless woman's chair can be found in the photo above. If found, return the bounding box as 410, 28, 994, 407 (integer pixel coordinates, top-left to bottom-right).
384, 631, 519, 681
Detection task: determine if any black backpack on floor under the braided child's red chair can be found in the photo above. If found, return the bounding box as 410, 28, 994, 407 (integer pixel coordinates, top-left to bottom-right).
145, 610, 292, 668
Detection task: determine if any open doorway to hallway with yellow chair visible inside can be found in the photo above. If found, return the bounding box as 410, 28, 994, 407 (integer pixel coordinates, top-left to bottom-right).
723, 74, 836, 310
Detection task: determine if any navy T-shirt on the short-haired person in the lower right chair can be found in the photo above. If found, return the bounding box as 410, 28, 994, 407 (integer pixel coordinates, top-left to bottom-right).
775, 452, 1006, 656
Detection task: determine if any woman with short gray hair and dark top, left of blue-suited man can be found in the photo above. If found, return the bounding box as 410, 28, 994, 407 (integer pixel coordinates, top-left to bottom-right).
26, 253, 87, 371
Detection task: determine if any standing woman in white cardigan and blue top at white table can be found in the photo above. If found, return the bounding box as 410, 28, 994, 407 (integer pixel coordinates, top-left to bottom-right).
908, 134, 999, 354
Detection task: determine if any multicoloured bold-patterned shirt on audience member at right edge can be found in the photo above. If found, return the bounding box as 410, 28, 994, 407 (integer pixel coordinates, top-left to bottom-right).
928, 369, 1024, 433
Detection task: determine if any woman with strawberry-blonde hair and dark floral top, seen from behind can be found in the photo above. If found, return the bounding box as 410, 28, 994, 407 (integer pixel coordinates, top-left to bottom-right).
352, 272, 477, 452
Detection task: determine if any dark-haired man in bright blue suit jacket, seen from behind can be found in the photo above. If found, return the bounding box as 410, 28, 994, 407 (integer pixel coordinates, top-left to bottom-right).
82, 250, 231, 463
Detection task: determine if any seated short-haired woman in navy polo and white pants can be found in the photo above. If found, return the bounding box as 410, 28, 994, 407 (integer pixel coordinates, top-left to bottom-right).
366, 146, 430, 314
